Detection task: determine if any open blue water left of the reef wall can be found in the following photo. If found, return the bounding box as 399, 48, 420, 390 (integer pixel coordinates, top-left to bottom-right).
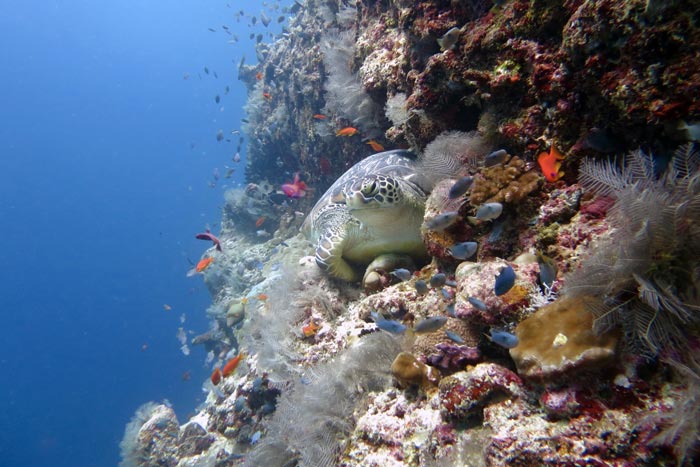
0, 0, 288, 467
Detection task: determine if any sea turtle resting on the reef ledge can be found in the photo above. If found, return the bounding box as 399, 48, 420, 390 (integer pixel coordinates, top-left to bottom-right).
303, 150, 431, 281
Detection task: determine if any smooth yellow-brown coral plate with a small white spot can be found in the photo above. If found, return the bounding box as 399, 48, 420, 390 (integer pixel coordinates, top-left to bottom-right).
510, 296, 619, 378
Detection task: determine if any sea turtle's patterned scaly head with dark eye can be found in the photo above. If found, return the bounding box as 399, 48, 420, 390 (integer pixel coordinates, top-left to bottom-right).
343, 175, 403, 212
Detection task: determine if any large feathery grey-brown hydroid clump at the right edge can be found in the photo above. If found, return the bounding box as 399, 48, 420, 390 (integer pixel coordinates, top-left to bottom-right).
565, 146, 700, 358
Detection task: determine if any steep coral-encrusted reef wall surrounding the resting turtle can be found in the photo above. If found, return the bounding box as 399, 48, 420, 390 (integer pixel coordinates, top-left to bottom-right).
122, 0, 700, 467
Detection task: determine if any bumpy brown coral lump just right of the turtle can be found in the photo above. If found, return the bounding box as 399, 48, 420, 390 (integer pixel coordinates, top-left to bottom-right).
469, 156, 542, 206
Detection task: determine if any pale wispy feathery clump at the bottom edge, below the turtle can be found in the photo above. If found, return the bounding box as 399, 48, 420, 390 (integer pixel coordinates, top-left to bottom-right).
245, 332, 401, 467
